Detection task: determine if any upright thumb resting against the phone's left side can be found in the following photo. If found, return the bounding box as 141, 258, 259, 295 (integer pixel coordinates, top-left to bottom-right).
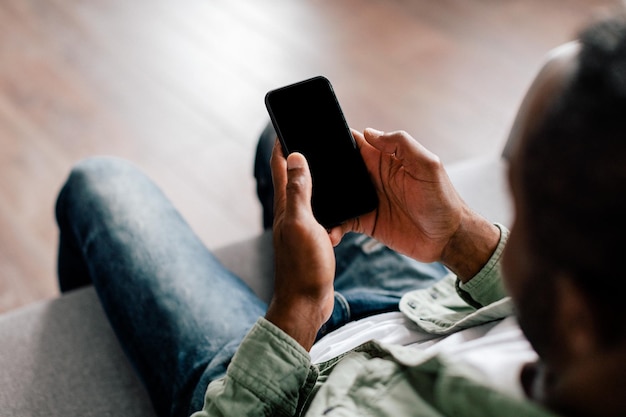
285, 152, 313, 218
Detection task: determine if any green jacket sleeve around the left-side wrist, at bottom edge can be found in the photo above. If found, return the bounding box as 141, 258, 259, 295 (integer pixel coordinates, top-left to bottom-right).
192, 318, 318, 417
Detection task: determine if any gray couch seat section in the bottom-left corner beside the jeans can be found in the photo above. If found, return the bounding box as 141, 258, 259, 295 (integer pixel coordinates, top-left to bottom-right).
0, 288, 155, 417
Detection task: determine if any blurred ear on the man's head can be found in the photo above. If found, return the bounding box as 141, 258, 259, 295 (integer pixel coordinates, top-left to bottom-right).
555, 274, 600, 360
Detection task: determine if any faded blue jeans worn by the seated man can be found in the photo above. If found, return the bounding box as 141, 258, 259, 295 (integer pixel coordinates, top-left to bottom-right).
57, 154, 445, 416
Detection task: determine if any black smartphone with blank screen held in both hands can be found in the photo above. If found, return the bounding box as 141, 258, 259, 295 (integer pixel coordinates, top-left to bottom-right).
265, 77, 378, 229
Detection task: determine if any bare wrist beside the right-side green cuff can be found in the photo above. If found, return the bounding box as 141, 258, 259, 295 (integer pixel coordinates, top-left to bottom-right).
441, 207, 500, 283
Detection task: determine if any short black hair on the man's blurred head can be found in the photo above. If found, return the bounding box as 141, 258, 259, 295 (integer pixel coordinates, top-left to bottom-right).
520, 13, 626, 342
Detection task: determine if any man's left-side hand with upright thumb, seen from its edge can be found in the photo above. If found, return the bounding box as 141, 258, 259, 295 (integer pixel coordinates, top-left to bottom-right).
265, 142, 335, 350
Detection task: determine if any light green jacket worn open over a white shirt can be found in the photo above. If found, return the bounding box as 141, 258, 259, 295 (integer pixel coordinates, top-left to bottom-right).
193, 227, 553, 417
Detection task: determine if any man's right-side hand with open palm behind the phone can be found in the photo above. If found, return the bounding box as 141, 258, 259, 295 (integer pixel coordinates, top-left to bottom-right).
331, 129, 499, 280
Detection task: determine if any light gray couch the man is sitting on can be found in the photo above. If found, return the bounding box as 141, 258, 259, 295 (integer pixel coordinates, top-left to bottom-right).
0, 151, 511, 417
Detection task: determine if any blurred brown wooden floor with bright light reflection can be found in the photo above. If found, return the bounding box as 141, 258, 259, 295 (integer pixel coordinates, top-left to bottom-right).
0, 0, 613, 311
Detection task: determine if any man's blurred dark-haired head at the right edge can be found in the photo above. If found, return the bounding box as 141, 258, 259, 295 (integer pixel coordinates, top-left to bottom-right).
504, 15, 626, 412
